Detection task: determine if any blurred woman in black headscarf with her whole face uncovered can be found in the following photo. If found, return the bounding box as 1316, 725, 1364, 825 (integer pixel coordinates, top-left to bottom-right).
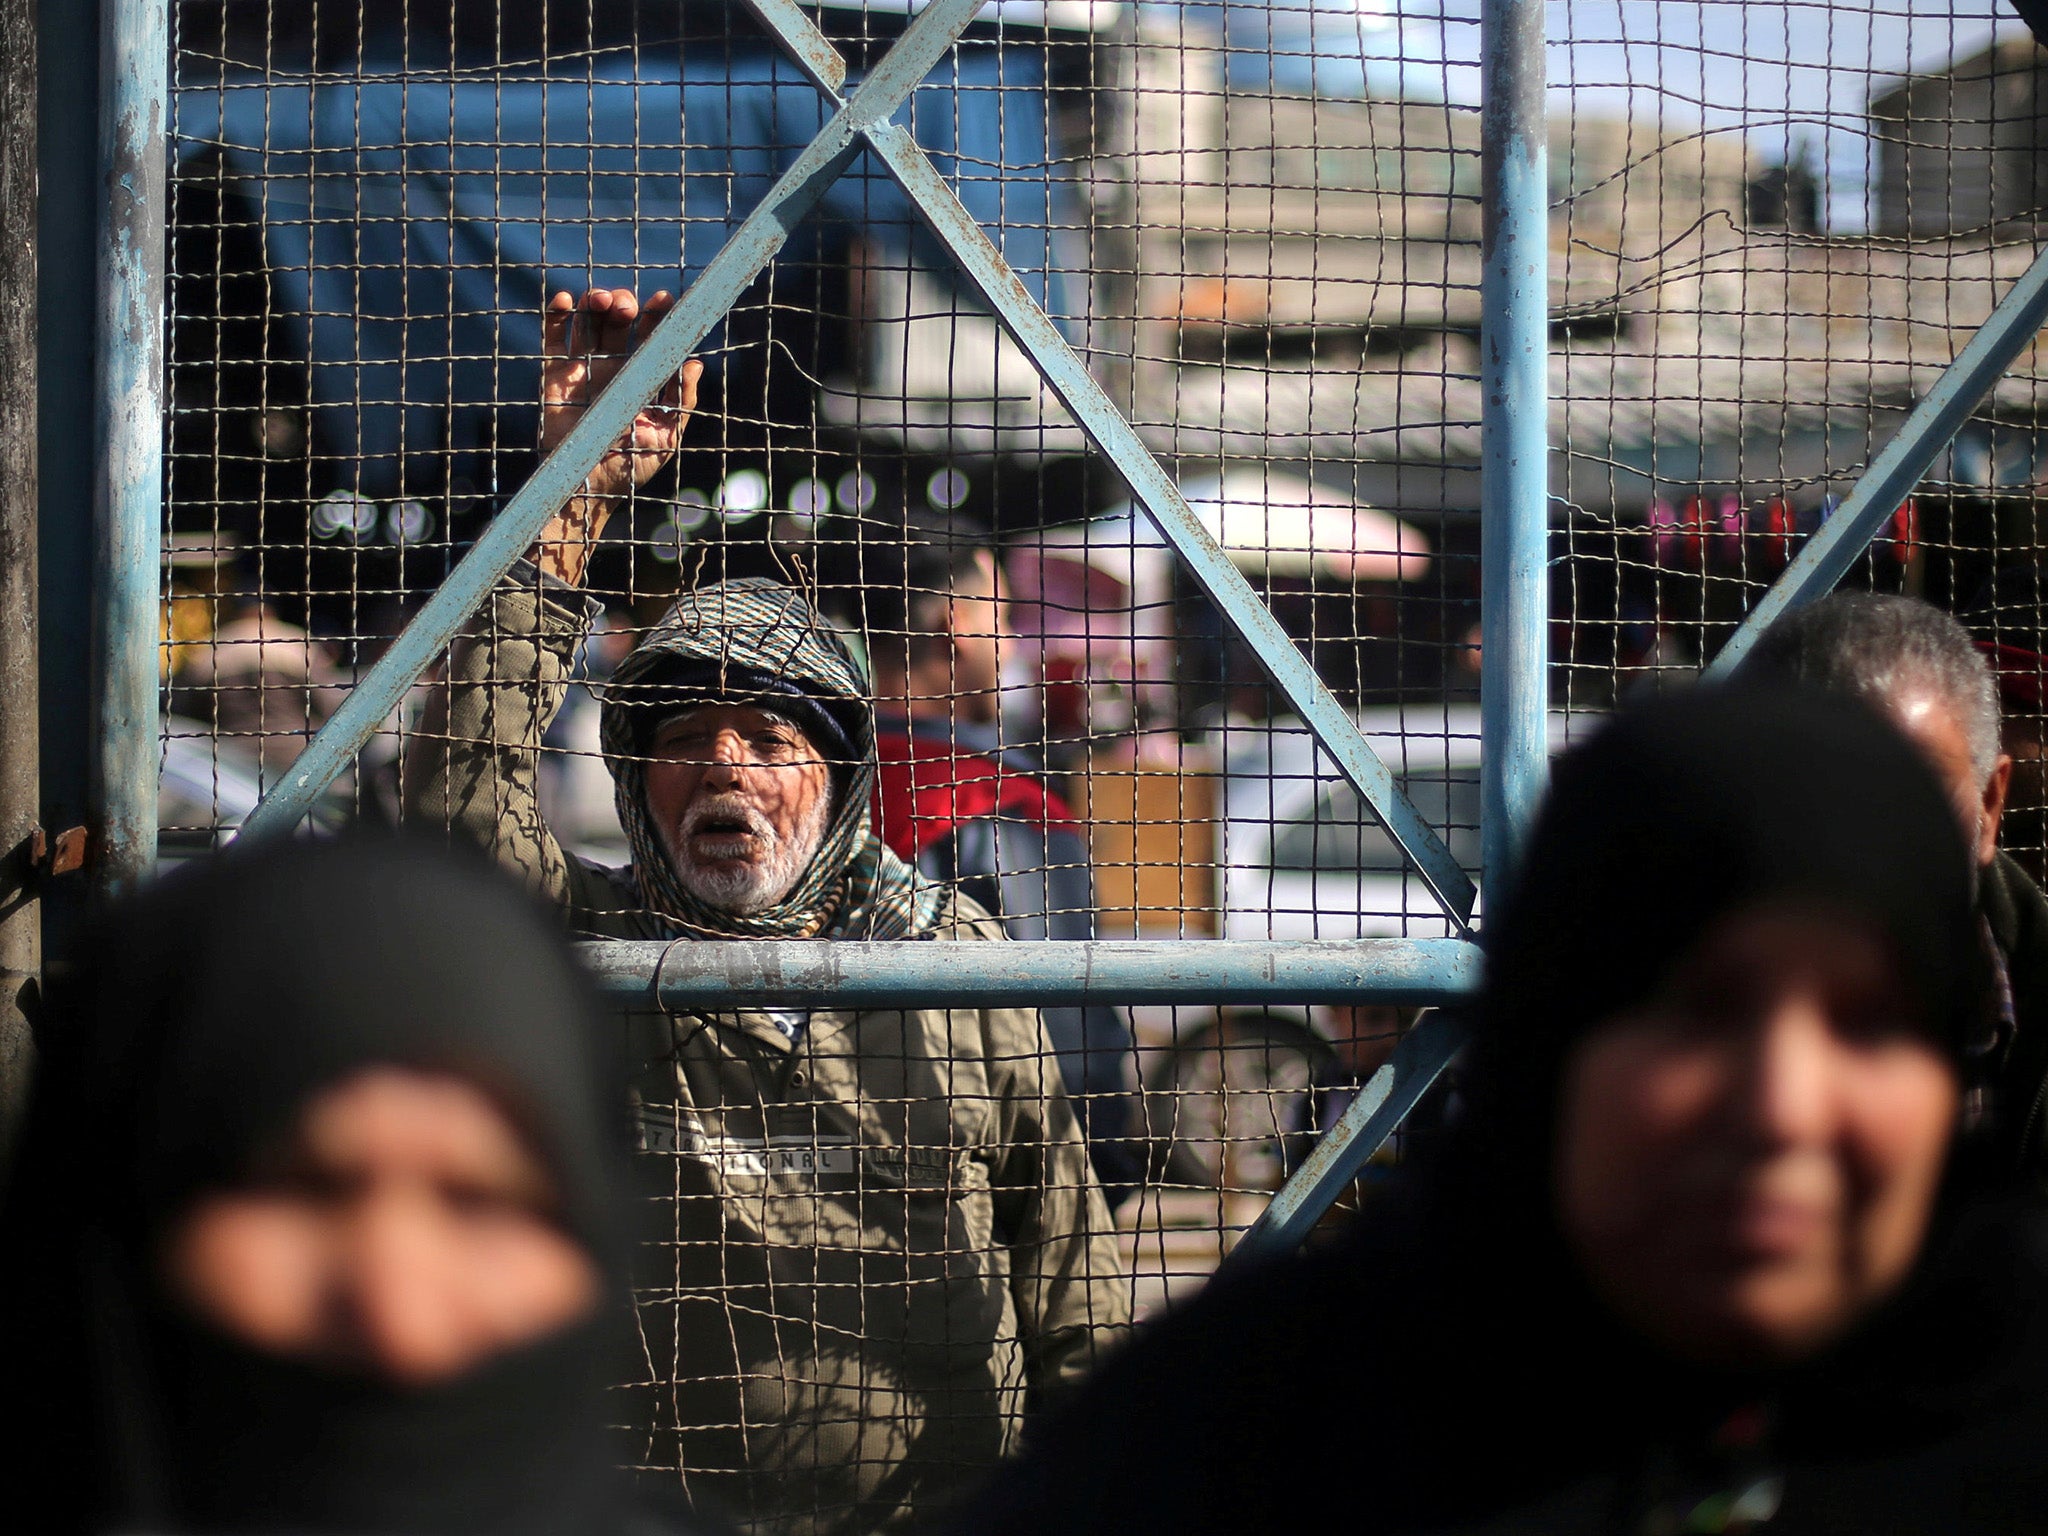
956, 690, 2048, 1536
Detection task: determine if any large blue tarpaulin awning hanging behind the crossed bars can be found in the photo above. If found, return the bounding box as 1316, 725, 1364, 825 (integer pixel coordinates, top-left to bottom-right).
172, 41, 1071, 500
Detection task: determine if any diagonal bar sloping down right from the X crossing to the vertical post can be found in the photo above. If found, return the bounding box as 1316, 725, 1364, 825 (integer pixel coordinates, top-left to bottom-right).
864, 123, 1482, 924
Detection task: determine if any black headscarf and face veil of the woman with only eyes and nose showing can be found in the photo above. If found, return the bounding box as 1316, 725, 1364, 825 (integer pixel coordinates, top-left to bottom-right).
0, 844, 647, 1536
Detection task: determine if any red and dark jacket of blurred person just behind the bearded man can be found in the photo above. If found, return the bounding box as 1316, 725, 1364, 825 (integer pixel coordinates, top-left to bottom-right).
874, 715, 1143, 1208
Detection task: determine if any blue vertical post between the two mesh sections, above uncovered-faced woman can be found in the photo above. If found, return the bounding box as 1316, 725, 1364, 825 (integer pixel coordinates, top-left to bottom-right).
1479, 0, 1550, 901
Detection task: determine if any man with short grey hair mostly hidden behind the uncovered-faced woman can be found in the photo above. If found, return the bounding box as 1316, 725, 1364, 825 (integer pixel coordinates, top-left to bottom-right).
1745, 592, 2048, 1180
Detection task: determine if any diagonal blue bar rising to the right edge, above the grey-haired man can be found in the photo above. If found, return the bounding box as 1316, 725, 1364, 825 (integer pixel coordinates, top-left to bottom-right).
1704, 248, 2048, 678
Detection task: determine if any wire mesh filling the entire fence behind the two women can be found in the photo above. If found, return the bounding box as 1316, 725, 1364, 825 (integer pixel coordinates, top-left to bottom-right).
162, 0, 2048, 1530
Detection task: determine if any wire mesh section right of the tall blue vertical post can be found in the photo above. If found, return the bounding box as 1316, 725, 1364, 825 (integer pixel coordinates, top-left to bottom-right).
1550, 2, 2048, 874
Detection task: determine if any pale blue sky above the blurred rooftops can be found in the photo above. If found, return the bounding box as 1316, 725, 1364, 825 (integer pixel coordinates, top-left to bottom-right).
1182, 0, 2025, 231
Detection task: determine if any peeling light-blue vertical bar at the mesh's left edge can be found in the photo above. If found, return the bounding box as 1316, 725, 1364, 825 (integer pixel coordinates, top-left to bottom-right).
88, 0, 170, 891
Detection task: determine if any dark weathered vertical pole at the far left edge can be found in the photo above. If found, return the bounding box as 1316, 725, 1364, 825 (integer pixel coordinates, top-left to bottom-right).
0, 0, 43, 1161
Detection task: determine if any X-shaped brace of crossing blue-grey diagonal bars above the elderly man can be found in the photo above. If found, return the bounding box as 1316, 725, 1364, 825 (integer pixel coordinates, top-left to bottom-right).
242, 0, 1477, 928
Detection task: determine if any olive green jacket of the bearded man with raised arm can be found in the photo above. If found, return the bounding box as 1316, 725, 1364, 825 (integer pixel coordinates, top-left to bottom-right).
408, 567, 1130, 1536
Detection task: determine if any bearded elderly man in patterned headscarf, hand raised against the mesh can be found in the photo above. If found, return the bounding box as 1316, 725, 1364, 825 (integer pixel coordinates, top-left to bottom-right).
408, 291, 1130, 1534
